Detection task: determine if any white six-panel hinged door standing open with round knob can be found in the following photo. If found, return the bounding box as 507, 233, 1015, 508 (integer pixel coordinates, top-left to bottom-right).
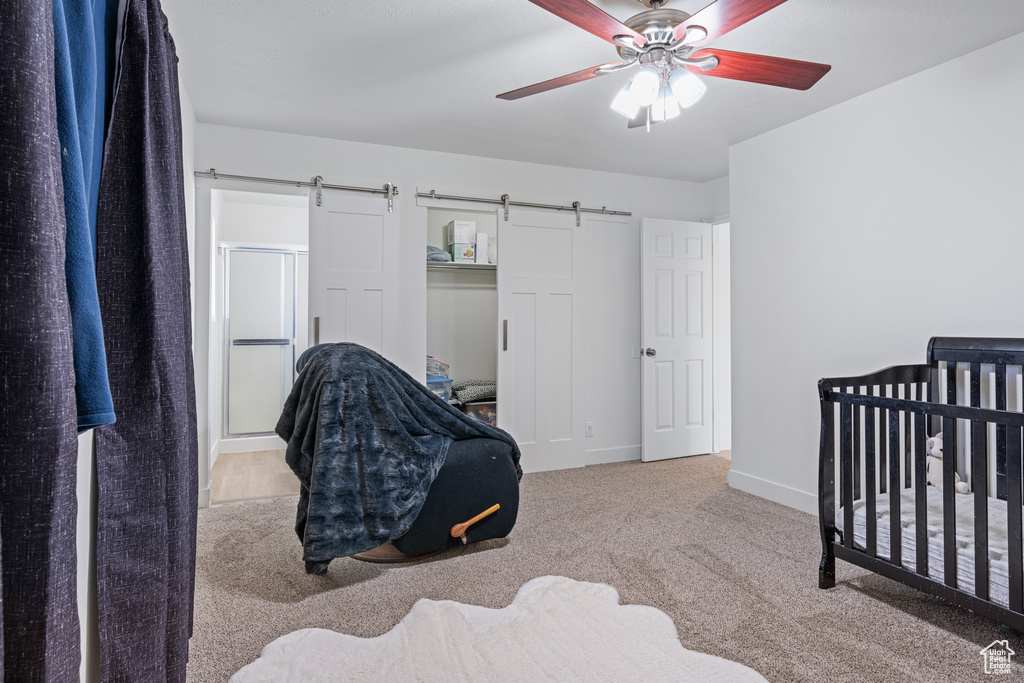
640, 218, 714, 462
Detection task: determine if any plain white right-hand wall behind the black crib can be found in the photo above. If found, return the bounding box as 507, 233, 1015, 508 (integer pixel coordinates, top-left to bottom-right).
729, 30, 1024, 512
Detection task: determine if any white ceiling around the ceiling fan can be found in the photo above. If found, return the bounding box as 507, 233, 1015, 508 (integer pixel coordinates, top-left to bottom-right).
163, 0, 1024, 182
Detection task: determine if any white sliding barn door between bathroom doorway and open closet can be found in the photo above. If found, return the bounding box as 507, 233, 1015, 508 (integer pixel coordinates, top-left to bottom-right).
309, 189, 400, 359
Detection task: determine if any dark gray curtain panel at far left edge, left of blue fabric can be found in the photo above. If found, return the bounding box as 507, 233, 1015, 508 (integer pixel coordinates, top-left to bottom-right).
0, 0, 80, 682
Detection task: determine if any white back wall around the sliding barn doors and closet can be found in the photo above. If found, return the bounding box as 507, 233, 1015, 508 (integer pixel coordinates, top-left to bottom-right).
196, 124, 703, 471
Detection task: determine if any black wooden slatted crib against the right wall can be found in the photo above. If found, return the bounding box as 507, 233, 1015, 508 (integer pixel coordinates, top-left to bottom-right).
818, 337, 1024, 632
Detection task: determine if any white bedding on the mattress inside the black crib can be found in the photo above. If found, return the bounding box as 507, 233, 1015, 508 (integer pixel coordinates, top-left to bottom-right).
837, 486, 1010, 607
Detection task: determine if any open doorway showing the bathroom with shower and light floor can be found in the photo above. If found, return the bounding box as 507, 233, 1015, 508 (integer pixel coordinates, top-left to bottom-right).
204, 190, 309, 503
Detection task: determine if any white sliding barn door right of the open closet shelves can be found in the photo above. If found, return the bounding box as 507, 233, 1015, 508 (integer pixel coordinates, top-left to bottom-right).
498, 209, 585, 472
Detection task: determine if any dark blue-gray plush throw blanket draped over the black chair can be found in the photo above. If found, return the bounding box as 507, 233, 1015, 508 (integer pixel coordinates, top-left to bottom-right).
275, 343, 522, 573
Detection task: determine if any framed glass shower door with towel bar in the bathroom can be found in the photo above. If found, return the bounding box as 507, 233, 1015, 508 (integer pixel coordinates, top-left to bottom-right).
223, 247, 298, 437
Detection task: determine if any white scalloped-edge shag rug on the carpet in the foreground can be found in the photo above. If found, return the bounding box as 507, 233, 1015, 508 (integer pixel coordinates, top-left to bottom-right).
231, 577, 767, 683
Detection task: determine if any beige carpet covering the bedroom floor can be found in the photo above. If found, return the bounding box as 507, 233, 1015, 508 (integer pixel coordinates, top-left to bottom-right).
188, 456, 1024, 683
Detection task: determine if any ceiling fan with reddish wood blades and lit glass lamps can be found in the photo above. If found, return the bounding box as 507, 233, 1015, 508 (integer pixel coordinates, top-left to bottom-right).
498, 0, 831, 130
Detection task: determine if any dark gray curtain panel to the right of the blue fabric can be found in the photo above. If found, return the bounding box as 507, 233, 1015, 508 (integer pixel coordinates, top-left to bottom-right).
94, 0, 198, 682
